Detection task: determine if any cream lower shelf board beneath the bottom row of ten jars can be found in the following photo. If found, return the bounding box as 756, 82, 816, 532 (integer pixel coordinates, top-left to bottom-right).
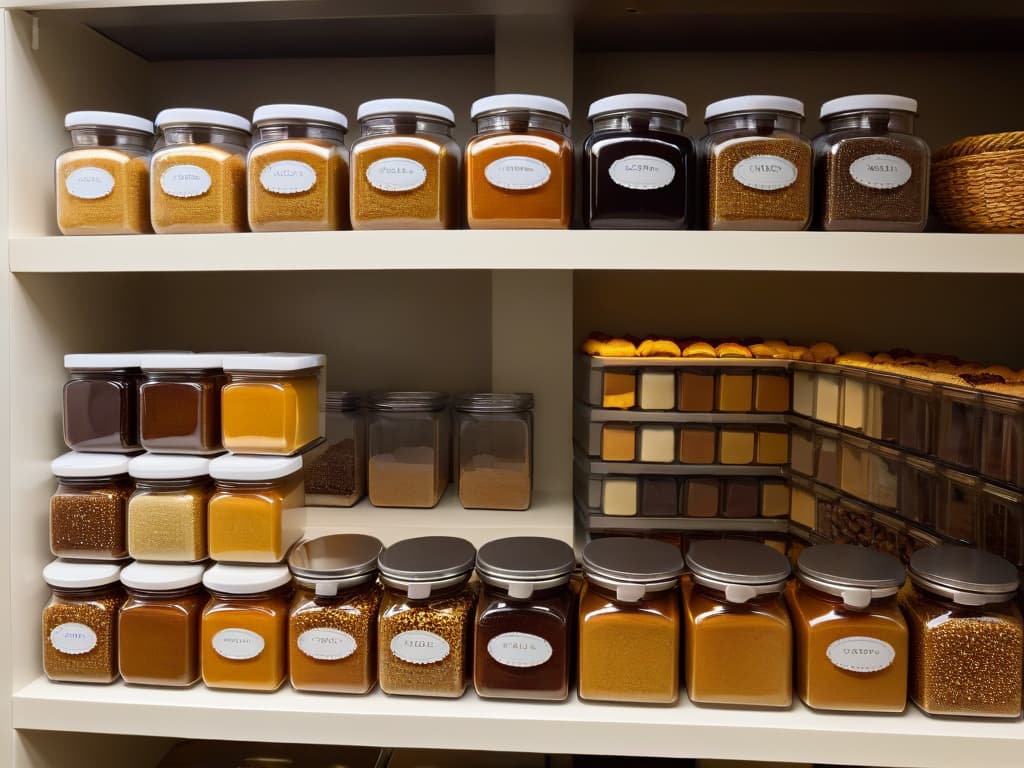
13, 678, 1024, 768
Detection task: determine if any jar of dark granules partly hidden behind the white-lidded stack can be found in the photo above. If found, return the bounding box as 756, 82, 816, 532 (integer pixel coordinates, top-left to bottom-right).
303, 392, 367, 507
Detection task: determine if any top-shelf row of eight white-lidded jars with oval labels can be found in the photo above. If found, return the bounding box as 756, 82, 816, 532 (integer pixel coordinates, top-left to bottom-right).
56, 93, 930, 234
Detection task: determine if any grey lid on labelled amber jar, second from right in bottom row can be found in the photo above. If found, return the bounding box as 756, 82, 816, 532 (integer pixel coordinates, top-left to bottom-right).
797, 544, 906, 608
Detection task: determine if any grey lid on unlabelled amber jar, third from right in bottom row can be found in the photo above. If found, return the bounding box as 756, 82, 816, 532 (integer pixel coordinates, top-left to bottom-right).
686, 539, 793, 603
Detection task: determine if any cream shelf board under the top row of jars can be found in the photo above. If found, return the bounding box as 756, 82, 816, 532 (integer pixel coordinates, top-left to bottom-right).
9, 229, 1024, 274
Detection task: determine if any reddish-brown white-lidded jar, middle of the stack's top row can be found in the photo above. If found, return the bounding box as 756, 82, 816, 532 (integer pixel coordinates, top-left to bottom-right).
138, 353, 225, 455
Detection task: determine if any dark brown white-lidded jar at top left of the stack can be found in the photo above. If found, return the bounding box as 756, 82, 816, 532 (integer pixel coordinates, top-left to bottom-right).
63, 354, 142, 454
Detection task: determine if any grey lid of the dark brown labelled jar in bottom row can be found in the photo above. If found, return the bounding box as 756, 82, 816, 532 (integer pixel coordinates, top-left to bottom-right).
476, 536, 575, 598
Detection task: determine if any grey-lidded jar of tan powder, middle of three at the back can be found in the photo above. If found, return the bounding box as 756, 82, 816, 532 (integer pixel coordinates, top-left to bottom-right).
367, 392, 452, 508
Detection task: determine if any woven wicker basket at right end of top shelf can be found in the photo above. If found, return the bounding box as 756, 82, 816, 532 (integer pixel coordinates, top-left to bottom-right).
932, 131, 1024, 232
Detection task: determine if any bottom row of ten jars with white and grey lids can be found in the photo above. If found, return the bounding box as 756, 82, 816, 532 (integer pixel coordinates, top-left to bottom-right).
43, 535, 1024, 718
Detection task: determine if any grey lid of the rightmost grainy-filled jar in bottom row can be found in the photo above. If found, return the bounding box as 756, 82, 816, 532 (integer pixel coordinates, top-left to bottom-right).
910, 544, 1020, 605
